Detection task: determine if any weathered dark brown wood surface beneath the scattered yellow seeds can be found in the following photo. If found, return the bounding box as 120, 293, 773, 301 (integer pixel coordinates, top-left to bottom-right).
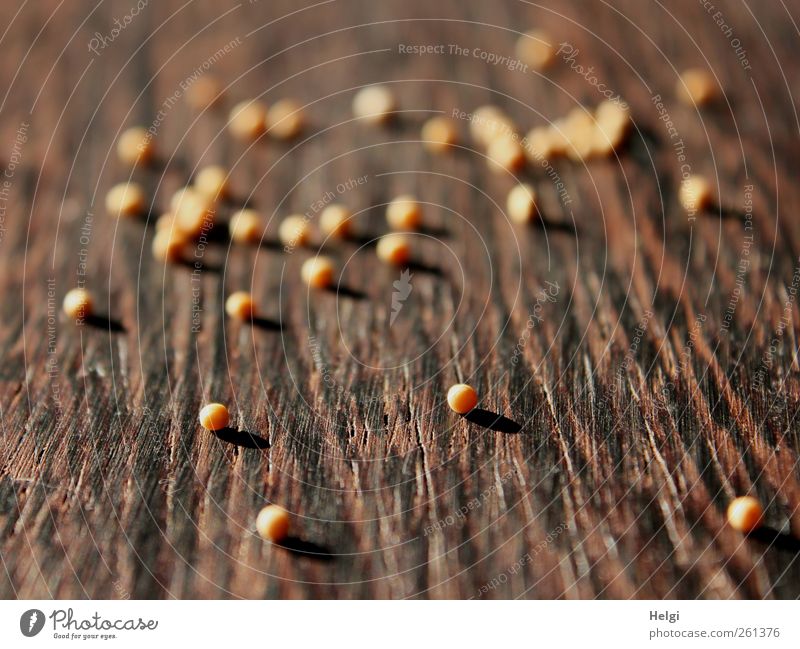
0, 0, 800, 598
